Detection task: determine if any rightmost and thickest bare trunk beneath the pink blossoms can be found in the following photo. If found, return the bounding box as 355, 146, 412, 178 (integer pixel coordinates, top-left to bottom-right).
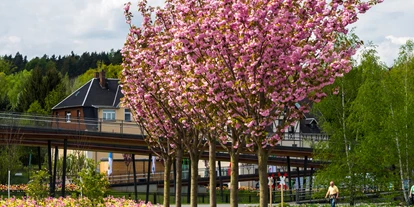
257, 146, 269, 207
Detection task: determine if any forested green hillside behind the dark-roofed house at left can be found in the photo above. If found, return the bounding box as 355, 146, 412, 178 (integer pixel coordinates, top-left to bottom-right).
0, 50, 122, 114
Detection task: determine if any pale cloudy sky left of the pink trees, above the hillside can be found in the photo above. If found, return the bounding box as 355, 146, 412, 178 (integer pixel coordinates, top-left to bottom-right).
0, 0, 128, 58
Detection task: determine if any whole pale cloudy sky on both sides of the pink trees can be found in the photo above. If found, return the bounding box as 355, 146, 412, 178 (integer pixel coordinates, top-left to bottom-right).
0, 0, 414, 66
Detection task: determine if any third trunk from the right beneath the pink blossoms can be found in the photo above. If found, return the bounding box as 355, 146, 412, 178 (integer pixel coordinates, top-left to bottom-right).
208, 139, 217, 207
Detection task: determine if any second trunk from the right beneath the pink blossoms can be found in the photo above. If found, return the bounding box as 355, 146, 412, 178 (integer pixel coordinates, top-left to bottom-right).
230, 153, 239, 207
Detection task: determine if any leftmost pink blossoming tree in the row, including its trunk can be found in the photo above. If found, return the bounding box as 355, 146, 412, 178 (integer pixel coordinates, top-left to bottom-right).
121, 4, 177, 206
